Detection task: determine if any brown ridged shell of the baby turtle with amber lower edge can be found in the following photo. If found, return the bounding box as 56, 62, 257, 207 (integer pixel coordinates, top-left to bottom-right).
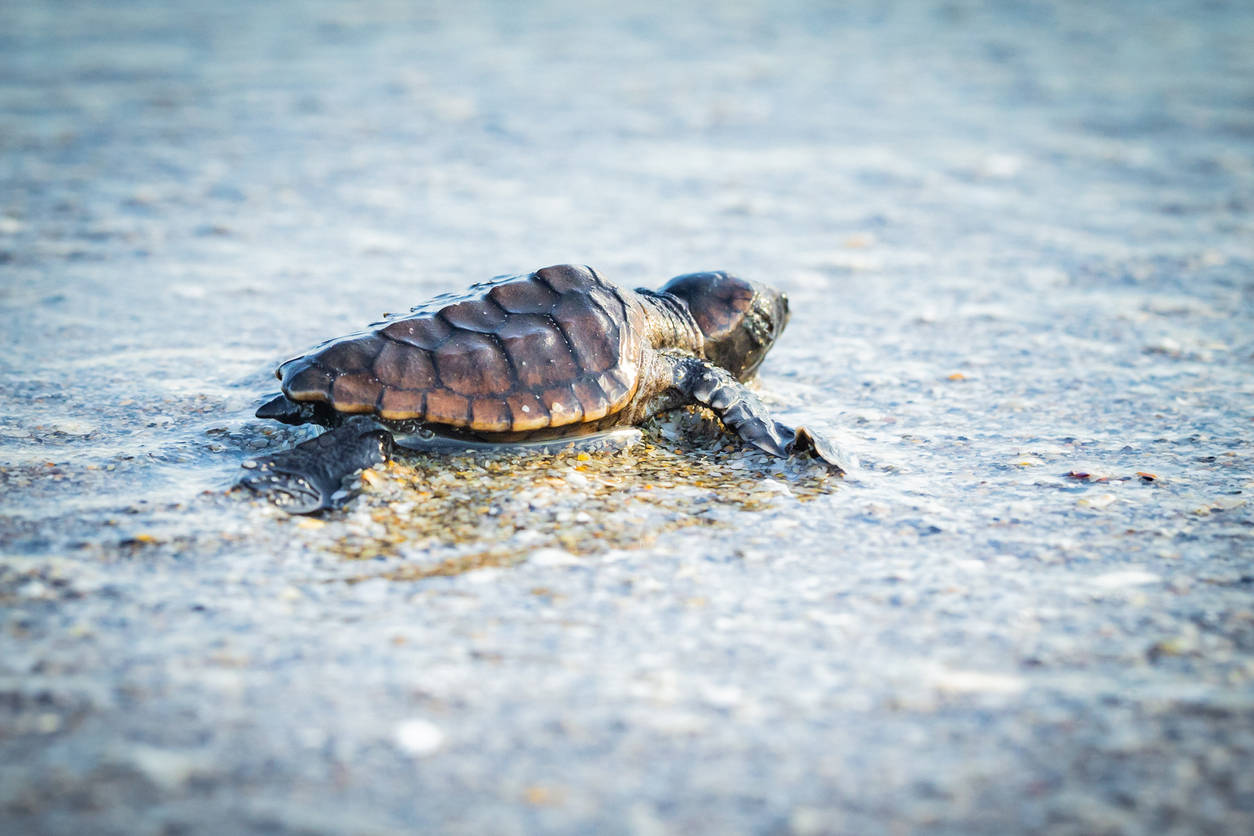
276, 264, 646, 432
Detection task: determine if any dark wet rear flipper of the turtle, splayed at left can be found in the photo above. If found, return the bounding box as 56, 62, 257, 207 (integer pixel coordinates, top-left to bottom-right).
240, 422, 393, 514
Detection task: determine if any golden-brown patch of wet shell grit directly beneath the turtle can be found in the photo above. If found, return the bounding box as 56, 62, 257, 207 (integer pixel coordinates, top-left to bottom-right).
291, 410, 838, 583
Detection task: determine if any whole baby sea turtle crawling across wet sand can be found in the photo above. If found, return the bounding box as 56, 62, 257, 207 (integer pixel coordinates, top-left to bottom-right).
241, 264, 844, 514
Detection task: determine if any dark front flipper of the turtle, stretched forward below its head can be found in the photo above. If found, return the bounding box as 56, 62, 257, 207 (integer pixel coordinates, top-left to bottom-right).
675, 358, 849, 475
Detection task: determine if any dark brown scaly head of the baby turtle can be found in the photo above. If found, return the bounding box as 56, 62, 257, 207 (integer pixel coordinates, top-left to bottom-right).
661, 271, 788, 380
